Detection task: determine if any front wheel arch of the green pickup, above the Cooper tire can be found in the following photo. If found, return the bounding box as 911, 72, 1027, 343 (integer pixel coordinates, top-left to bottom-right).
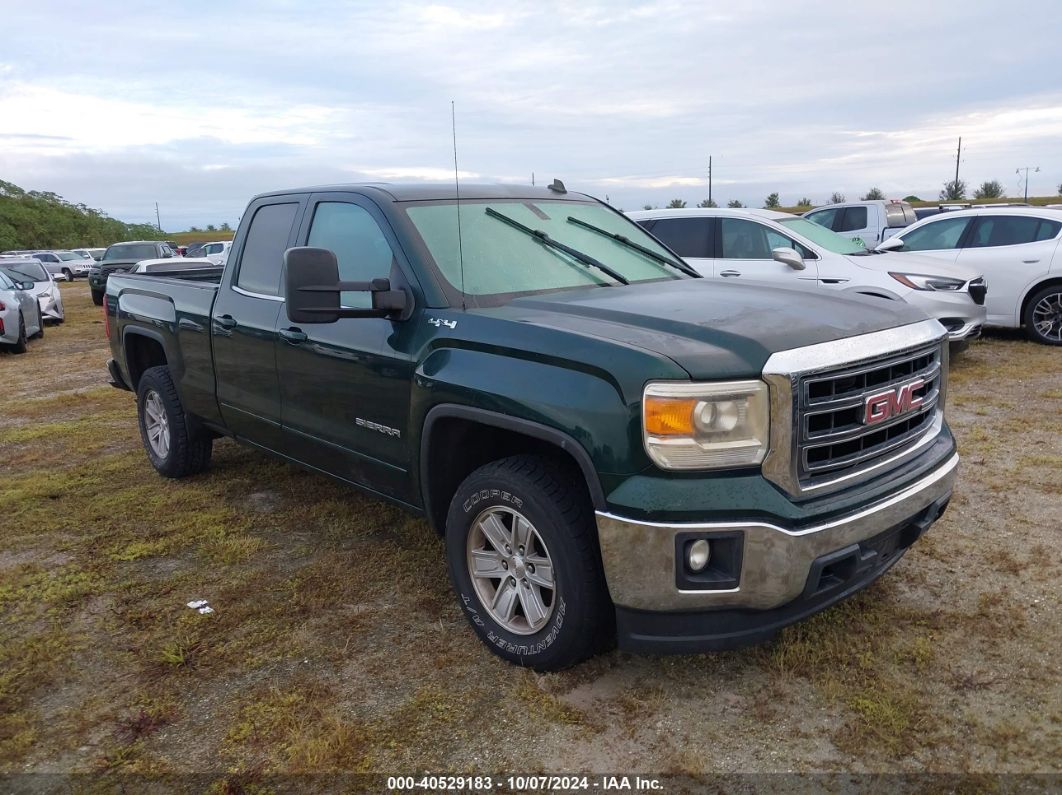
419, 404, 605, 534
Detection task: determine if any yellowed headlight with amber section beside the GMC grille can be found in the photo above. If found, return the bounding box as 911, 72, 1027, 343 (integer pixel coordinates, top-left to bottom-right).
641, 381, 770, 469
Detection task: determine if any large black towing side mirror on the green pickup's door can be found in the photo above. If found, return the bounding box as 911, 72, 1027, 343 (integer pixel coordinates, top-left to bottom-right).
284, 246, 410, 323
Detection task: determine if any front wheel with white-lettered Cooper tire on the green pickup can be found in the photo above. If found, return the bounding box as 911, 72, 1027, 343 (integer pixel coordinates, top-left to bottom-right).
446, 455, 615, 671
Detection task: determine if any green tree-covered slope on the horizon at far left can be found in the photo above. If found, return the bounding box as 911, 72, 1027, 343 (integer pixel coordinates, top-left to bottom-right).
0, 179, 159, 250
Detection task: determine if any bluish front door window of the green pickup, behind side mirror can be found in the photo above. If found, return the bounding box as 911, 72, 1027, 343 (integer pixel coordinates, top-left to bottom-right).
306, 202, 394, 309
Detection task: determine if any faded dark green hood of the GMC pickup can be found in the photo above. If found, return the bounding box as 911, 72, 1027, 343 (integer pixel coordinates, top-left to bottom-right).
492, 279, 930, 379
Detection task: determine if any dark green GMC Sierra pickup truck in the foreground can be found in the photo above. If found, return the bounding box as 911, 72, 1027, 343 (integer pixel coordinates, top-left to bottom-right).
104, 184, 958, 671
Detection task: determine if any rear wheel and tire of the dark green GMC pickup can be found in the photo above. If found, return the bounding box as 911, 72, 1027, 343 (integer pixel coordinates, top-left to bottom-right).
137, 367, 213, 478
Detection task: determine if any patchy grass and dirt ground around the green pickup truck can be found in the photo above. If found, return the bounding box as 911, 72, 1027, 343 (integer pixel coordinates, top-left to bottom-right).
0, 281, 1062, 791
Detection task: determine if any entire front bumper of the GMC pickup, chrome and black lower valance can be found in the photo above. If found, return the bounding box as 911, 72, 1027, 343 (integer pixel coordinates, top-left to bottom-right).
597, 454, 959, 652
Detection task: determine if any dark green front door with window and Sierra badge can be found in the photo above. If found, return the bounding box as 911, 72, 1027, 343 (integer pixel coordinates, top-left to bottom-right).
276, 193, 413, 501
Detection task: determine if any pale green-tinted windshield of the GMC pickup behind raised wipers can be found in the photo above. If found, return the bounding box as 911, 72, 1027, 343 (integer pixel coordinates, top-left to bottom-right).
406, 200, 686, 297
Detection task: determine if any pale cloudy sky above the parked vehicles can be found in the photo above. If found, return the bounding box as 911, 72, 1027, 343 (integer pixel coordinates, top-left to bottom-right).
0, 0, 1062, 231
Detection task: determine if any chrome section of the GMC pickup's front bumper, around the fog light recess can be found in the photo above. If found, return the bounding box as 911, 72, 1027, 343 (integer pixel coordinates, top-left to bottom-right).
597, 454, 959, 611
